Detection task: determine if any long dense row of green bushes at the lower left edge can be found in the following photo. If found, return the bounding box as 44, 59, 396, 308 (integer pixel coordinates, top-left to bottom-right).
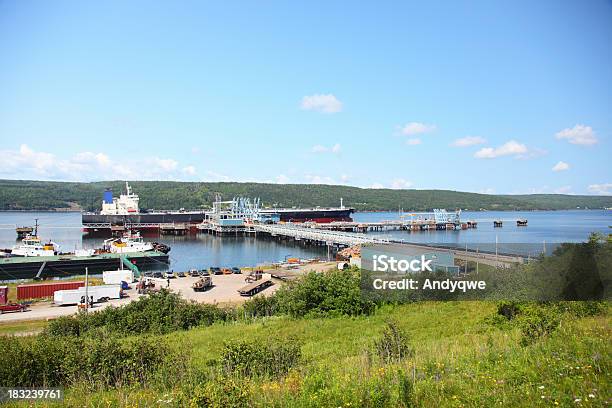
0, 335, 182, 388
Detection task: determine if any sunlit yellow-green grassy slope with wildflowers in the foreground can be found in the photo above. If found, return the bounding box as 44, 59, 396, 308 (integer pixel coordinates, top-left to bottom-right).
5, 302, 612, 407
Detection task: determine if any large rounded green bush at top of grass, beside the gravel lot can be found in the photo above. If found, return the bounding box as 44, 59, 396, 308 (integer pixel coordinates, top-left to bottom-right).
275, 270, 375, 317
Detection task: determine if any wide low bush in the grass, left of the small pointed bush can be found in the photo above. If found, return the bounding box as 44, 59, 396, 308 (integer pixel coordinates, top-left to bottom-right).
220, 340, 301, 378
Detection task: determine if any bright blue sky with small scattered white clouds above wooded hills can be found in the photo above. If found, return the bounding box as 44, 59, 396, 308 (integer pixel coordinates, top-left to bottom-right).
0, 0, 612, 195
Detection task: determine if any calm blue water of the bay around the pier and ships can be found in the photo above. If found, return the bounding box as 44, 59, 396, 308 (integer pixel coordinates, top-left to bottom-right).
0, 210, 612, 270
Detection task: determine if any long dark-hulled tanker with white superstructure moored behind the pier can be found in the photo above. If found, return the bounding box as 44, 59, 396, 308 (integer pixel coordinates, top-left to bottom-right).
82, 182, 355, 235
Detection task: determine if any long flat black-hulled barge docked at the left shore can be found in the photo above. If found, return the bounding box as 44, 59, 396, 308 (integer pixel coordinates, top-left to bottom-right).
0, 251, 169, 280
